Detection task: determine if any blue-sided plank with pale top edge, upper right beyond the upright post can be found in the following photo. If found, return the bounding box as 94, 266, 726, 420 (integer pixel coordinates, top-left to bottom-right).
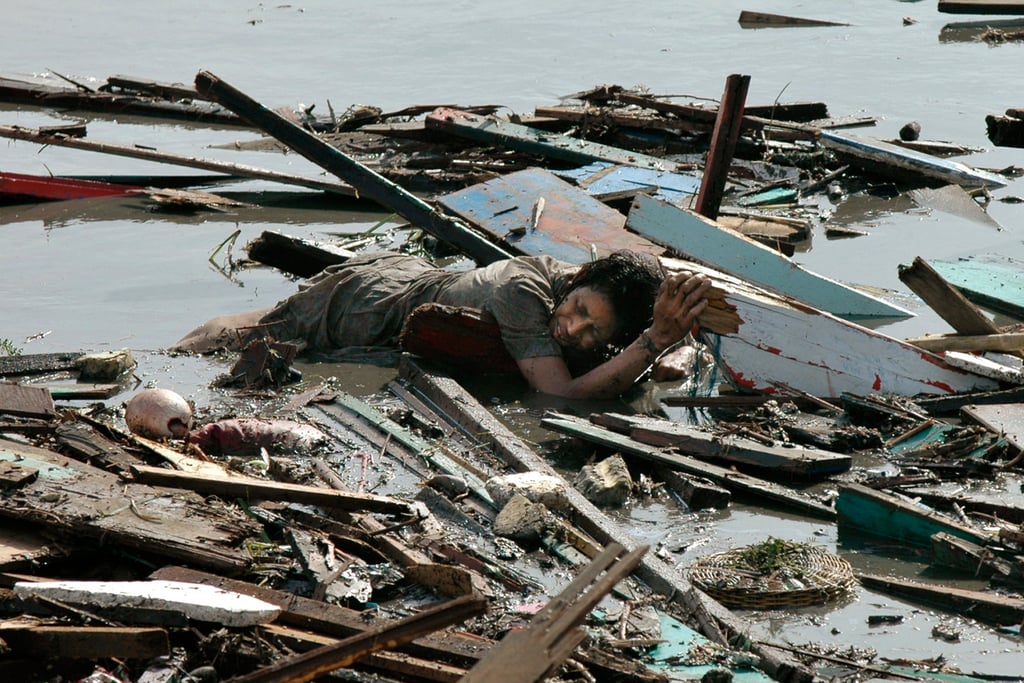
820, 131, 1007, 188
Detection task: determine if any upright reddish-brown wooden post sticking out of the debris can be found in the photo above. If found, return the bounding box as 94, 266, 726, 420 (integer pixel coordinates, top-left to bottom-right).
693, 74, 751, 220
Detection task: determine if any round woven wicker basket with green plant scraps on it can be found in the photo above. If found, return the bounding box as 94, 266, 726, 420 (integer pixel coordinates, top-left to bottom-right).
689, 539, 857, 609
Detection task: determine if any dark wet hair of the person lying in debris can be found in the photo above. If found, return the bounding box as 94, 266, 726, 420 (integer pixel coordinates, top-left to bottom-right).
566, 249, 665, 348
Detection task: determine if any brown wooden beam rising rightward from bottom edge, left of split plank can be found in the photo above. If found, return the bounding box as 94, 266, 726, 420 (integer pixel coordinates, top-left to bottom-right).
232, 595, 487, 683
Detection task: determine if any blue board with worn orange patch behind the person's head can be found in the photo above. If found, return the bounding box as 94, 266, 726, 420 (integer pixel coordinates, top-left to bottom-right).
438, 168, 665, 263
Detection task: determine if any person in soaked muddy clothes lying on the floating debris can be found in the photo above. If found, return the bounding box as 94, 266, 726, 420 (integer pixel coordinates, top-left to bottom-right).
171, 250, 712, 398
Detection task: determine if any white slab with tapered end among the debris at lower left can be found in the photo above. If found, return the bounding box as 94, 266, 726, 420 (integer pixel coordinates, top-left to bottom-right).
14, 581, 281, 627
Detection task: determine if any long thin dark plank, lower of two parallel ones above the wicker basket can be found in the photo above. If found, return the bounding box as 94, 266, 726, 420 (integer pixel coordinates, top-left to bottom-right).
541, 413, 836, 519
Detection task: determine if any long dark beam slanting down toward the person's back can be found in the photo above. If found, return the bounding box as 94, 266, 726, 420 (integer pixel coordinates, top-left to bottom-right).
196, 72, 508, 264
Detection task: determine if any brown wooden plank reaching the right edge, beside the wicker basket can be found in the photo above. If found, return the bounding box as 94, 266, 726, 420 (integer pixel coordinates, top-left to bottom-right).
857, 573, 1024, 626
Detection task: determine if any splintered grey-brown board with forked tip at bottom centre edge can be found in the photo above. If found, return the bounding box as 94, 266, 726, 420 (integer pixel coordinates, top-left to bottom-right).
462, 544, 647, 683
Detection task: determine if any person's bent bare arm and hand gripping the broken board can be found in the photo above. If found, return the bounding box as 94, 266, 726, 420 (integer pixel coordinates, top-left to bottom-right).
518, 270, 711, 398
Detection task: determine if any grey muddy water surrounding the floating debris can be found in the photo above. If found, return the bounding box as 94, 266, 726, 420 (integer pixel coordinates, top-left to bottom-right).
6, 0, 1024, 676
